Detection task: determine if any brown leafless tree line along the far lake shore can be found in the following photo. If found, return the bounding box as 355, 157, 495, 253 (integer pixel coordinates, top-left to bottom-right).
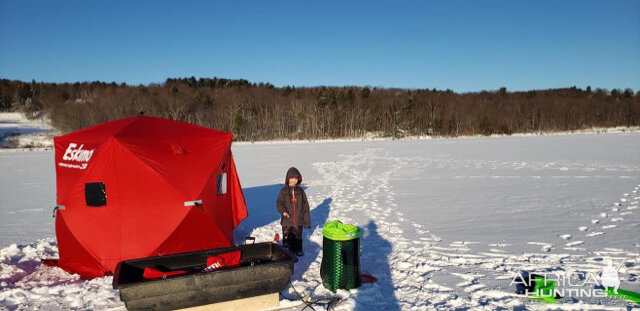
0, 77, 640, 141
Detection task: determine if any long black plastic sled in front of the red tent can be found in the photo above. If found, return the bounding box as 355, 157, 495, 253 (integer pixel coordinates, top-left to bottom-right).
113, 242, 293, 310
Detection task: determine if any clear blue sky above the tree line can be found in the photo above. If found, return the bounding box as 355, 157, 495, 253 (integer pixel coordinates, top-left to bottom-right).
0, 0, 640, 92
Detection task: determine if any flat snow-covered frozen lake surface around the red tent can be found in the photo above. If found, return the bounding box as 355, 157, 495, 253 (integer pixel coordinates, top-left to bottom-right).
0, 133, 640, 310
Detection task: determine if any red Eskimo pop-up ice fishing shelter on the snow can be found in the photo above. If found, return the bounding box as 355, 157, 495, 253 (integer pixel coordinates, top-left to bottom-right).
54, 116, 247, 279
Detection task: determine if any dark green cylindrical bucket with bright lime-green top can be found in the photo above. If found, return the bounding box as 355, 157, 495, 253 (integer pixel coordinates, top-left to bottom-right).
320, 220, 360, 292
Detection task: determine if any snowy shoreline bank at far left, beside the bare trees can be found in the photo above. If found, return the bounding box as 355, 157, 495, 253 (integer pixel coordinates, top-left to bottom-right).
0, 112, 53, 148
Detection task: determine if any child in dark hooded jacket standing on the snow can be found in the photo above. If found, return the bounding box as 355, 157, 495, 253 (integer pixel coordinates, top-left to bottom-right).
276, 167, 311, 256
